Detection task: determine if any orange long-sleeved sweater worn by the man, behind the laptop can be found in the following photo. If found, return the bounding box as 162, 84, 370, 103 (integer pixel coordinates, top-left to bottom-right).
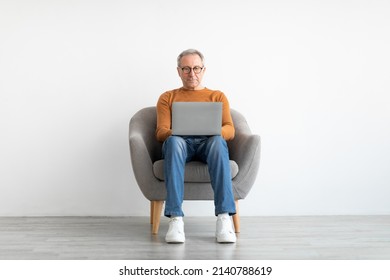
156, 88, 234, 142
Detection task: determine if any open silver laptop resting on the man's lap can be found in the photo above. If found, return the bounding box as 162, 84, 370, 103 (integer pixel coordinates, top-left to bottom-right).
172, 102, 222, 136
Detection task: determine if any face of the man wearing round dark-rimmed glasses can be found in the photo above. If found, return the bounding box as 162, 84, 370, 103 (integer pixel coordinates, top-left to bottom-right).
177, 54, 206, 90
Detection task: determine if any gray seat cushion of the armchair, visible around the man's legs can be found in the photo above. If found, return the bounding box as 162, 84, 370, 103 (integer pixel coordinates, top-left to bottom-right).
153, 159, 238, 183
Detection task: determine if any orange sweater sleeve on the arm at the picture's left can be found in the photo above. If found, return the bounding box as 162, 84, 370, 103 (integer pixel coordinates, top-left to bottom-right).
156, 93, 172, 142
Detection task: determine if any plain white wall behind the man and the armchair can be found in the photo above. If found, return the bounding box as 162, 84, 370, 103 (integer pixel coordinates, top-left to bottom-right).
0, 0, 390, 216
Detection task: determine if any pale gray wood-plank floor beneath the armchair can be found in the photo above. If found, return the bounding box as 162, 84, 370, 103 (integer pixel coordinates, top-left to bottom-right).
0, 216, 390, 260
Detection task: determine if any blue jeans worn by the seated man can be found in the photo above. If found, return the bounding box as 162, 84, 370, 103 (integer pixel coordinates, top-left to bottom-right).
163, 136, 236, 217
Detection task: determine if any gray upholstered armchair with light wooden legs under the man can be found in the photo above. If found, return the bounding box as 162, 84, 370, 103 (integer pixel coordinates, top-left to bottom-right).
129, 107, 260, 234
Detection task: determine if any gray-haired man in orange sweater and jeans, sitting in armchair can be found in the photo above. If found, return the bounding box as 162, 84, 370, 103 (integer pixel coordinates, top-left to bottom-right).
156, 49, 236, 243
